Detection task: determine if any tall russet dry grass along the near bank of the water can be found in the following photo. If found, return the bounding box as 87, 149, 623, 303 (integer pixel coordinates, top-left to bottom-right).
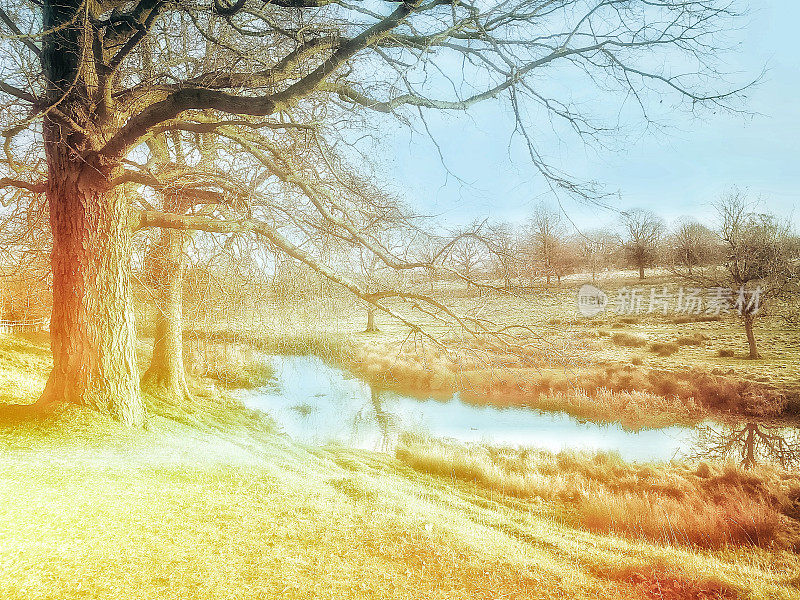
397, 437, 800, 551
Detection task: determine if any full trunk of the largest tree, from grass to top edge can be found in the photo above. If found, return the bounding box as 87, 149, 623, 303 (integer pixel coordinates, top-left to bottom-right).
34, 0, 144, 425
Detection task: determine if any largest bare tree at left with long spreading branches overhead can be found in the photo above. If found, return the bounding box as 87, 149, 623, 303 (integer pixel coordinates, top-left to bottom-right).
0, 0, 752, 423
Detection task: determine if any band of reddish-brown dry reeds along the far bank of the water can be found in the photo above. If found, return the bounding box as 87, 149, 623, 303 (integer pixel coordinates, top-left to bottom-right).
338, 338, 787, 428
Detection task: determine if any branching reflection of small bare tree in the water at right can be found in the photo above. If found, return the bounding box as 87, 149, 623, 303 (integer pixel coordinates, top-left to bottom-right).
691, 421, 800, 469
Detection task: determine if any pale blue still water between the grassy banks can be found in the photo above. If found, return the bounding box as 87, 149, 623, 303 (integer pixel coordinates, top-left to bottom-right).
243, 356, 708, 461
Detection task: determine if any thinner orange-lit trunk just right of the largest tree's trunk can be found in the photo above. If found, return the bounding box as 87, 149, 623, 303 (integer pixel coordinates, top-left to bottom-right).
142, 229, 191, 399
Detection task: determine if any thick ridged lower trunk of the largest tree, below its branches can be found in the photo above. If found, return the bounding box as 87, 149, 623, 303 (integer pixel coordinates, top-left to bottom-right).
40, 155, 144, 425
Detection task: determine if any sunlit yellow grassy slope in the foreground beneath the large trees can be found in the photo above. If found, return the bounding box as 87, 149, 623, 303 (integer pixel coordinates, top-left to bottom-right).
0, 338, 800, 599
